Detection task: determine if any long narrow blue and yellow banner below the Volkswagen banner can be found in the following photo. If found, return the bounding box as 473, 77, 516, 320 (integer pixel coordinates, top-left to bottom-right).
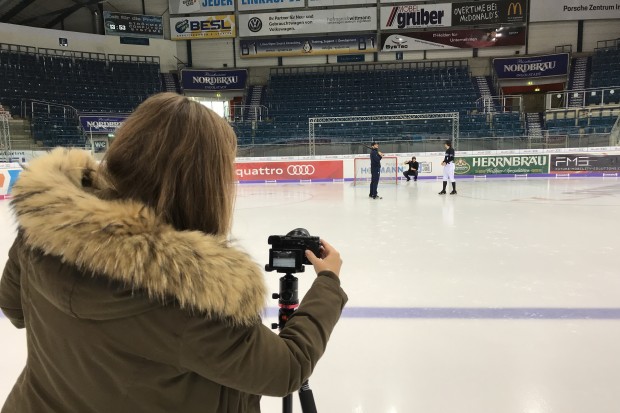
239, 34, 377, 57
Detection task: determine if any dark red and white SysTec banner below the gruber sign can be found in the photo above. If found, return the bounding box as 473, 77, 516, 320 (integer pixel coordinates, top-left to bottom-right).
381, 27, 525, 52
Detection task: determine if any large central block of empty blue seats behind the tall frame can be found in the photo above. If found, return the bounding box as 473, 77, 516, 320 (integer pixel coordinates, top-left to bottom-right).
238, 65, 502, 143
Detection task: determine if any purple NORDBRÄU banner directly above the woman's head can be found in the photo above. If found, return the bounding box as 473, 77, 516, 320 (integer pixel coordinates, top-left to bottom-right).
181, 69, 248, 90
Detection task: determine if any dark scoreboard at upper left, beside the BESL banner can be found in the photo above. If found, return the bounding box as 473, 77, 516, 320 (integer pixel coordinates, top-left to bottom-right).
103, 11, 164, 39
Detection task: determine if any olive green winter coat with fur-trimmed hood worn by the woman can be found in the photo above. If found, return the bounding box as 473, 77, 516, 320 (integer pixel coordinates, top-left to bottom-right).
0, 150, 347, 413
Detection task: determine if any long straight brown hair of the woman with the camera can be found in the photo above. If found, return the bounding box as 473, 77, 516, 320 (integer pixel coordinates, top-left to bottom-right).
105, 93, 237, 235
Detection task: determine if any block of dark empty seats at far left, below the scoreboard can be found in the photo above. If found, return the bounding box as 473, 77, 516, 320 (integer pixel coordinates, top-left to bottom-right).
0, 48, 161, 146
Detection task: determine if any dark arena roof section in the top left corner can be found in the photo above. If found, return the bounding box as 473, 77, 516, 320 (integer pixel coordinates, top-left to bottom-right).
0, 0, 168, 28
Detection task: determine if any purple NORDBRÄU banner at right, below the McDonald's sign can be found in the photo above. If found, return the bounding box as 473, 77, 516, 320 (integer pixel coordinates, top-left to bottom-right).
493, 53, 569, 79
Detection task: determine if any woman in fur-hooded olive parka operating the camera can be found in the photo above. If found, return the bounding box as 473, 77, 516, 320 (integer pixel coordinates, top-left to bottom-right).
0, 93, 347, 413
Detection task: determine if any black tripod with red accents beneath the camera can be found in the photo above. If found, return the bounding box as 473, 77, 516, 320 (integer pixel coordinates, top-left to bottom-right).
271, 272, 317, 413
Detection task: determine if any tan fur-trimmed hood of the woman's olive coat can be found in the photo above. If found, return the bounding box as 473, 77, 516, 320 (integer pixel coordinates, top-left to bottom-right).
11, 149, 266, 325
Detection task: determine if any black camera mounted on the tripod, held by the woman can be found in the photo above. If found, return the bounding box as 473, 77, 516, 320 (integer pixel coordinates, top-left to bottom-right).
265, 228, 321, 273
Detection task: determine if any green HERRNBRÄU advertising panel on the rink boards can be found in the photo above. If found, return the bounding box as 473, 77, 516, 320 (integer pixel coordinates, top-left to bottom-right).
454, 155, 549, 175
